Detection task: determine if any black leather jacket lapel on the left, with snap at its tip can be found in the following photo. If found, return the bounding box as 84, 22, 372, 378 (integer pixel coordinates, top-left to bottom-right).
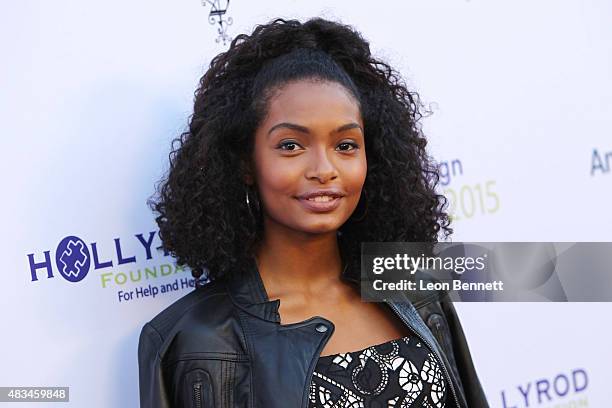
228, 253, 334, 408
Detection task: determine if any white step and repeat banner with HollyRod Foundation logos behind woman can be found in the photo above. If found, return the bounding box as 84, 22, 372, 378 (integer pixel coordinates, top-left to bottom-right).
0, 0, 612, 408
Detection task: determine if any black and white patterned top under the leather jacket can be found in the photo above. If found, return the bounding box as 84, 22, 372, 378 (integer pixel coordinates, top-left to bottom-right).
308, 336, 452, 408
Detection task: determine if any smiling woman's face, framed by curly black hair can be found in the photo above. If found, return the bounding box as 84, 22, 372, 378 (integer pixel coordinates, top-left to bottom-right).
253, 80, 367, 234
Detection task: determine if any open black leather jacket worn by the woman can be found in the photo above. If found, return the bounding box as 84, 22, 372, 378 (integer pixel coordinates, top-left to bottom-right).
138, 261, 488, 408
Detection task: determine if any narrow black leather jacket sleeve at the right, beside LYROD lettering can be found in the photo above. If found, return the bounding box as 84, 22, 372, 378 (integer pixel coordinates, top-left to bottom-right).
440, 297, 489, 408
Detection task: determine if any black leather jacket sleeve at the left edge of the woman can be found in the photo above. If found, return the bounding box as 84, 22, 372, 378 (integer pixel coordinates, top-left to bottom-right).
138, 323, 171, 408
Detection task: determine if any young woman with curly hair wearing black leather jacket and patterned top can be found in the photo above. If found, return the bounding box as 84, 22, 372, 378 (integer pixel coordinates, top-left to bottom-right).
138, 18, 487, 408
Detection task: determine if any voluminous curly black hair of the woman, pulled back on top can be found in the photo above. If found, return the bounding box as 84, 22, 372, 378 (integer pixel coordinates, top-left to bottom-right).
147, 18, 453, 281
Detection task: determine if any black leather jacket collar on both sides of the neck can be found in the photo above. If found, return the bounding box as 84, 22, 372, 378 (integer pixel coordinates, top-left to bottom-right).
226, 250, 359, 324
